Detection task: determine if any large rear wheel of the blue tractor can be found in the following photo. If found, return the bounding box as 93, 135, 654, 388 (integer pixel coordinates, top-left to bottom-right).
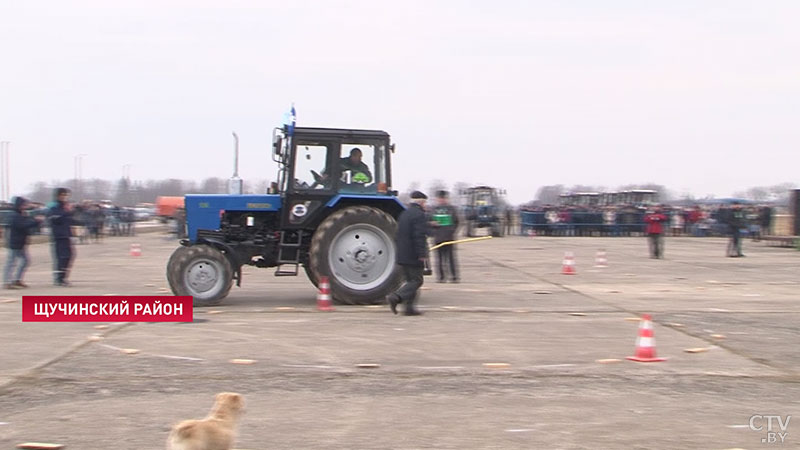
309, 206, 400, 305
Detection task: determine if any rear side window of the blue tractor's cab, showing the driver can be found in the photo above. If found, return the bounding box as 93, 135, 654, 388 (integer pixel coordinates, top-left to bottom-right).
339, 143, 376, 193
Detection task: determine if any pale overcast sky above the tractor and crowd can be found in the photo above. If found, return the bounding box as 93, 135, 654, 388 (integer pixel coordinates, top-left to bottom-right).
0, 0, 800, 203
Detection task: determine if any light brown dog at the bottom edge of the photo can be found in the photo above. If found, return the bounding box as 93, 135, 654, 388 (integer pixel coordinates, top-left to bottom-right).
167, 392, 244, 450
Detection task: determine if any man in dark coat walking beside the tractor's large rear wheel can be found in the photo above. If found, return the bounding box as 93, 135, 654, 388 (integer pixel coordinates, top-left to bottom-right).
386, 191, 428, 316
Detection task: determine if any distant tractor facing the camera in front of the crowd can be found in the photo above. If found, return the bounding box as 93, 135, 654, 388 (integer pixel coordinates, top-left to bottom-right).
462, 186, 507, 237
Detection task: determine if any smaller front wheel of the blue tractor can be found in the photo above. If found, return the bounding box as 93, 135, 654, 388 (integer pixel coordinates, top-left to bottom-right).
167, 245, 233, 306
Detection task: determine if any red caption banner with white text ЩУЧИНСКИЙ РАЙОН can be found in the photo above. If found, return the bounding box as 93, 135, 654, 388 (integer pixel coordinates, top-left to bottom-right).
22, 295, 194, 322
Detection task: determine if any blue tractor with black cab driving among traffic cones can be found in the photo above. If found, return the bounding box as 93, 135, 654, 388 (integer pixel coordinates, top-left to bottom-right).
167, 127, 405, 305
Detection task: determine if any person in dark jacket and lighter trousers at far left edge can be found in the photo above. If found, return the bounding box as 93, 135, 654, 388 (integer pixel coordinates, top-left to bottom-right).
3, 197, 39, 289
